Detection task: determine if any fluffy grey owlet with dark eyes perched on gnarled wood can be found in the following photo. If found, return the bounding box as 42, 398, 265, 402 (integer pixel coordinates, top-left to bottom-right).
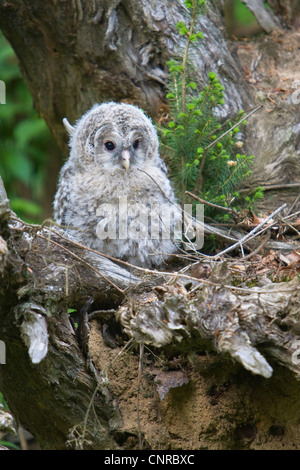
54, 102, 181, 267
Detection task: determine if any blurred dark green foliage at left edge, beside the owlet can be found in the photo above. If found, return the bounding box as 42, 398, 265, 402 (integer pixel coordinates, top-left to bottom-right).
0, 33, 51, 222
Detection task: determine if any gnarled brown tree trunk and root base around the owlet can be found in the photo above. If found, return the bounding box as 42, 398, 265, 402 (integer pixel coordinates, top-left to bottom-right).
0, 0, 300, 449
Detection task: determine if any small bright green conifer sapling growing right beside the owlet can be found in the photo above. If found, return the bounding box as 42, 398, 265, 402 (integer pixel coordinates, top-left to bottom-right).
160, 0, 261, 220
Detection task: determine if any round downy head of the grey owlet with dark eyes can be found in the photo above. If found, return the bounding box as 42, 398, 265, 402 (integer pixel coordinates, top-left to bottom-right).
63, 102, 159, 172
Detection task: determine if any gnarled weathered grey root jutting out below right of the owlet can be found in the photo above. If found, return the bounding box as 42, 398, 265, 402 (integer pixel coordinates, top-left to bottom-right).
119, 263, 300, 378
